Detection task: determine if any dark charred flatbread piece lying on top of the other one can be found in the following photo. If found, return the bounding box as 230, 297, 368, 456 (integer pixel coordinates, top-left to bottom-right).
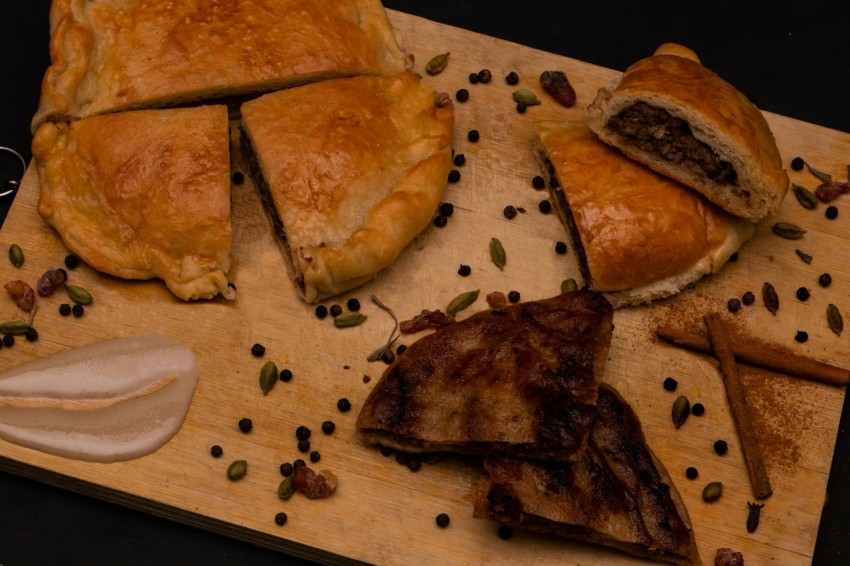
357, 291, 613, 459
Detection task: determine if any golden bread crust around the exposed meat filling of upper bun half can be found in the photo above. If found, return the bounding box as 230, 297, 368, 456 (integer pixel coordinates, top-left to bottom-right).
587, 44, 788, 222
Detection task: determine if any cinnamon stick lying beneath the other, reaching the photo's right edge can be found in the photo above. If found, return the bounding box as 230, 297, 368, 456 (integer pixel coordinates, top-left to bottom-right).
656, 325, 850, 387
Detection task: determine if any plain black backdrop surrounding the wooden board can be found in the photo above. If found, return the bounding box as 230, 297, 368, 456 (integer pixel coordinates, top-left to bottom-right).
0, 0, 850, 566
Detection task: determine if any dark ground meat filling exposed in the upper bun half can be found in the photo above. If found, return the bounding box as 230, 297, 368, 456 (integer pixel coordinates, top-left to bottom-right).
607, 102, 738, 185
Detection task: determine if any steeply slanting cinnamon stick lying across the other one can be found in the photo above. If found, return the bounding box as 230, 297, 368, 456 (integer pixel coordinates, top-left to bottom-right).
705, 313, 773, 499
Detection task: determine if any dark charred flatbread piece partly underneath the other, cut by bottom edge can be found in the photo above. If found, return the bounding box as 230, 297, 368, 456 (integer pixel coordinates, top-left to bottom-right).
475, 384, 700, 564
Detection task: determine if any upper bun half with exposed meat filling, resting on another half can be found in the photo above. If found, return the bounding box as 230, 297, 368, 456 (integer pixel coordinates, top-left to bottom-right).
587, 44, 788, 222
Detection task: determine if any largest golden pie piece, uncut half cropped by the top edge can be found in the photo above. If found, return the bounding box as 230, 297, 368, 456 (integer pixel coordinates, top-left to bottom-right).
33, 0, 412, 129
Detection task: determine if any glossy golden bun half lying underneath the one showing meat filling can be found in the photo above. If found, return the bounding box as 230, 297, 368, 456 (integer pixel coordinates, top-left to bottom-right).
535, 121, 753, 307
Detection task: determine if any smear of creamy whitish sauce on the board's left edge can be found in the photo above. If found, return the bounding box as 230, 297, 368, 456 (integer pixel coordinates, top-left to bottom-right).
0, 335, 199, 462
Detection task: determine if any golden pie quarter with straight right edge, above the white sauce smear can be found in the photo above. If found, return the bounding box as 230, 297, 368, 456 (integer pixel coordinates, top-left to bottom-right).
32, 105, 235, 300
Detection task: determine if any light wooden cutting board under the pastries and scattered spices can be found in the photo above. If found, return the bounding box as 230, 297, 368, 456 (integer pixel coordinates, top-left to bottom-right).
0, 12, 850, 565
